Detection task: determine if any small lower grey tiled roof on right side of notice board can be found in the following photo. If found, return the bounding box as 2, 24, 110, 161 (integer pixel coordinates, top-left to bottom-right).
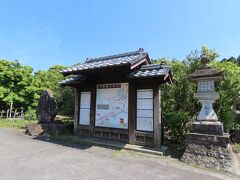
129, 64, 171, 78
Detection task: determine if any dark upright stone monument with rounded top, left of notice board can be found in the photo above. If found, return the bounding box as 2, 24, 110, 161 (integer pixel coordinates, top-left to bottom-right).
37, 90, 58, 123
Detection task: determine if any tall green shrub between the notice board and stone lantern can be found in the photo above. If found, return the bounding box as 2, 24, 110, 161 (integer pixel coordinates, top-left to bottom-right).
158, 61, 197, 146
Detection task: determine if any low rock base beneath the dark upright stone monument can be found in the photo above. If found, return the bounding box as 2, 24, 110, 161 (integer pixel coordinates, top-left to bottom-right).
25, 123, 66, 136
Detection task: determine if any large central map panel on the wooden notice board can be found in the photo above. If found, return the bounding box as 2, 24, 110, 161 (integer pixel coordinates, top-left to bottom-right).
95, 83, 128, 129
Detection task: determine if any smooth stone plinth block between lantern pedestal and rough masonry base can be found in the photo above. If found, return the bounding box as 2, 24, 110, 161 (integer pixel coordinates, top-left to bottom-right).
191, 121, 223, 136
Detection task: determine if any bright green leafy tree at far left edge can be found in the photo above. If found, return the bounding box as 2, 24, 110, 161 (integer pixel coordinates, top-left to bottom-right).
0, 60, 42, 110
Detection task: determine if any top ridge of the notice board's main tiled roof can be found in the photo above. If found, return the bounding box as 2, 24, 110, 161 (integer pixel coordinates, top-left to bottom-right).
85, 48, 146, 63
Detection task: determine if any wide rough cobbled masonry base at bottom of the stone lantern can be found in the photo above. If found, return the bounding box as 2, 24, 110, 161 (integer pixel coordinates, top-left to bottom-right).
181, 133, 238, 173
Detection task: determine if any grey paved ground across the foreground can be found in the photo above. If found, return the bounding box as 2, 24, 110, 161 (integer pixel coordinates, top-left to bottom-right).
0, 128, 236, 180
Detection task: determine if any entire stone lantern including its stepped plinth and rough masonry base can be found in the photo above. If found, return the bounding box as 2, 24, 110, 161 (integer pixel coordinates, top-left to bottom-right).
181, 57, 238, 172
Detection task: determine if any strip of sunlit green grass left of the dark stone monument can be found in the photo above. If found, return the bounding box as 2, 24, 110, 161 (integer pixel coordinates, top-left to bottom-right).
0, 119, 37, 129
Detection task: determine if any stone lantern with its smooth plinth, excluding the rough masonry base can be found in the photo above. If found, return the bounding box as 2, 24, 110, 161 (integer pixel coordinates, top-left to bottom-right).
187, 57, 224, 135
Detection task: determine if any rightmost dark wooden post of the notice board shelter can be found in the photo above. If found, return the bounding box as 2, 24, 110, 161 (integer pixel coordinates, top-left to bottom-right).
153, 84, 161, 148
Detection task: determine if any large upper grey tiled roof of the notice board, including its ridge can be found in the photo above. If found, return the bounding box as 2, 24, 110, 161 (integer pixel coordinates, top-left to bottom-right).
61, 48, 149, 75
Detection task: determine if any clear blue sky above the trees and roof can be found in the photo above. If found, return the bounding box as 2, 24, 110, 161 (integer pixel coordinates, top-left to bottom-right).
0, 0, 240, 71
